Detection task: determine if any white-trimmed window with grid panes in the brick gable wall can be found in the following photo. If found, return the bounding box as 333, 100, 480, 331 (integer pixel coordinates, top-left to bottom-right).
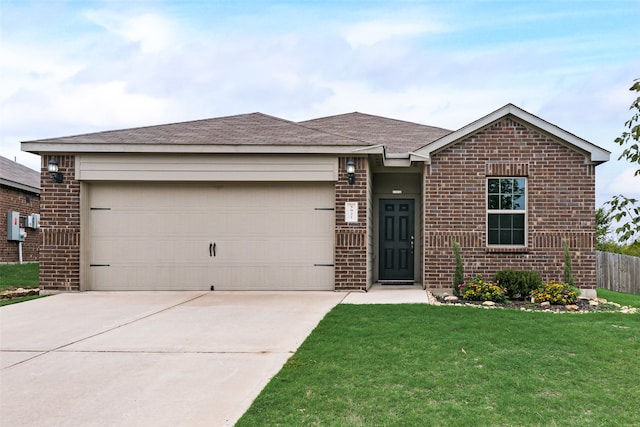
487, 177, 527, 246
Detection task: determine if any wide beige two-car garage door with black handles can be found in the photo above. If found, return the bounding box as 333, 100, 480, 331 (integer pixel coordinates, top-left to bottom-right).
85, 183, 335, 290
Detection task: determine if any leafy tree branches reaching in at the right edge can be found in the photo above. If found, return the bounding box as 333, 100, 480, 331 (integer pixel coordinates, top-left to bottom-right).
607, 79, 640, 242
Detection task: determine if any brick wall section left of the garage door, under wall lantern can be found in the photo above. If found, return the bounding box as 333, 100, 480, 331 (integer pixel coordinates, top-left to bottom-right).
40, 155, 80, 291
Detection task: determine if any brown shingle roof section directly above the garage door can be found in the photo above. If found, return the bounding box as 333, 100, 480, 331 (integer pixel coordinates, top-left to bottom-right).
30, 113, 367, 146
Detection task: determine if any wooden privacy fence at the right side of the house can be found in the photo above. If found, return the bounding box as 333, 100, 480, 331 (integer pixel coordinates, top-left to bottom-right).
596, 251, 640, 295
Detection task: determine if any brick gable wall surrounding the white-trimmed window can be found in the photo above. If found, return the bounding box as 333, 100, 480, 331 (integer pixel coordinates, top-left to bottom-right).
424, 118, 596, 289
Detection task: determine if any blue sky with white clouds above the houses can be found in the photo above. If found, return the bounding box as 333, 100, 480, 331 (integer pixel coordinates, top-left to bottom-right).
0, 0, 640, 206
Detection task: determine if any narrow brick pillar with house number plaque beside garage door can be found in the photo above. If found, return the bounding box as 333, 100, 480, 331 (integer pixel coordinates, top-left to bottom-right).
334, 157, 368, 290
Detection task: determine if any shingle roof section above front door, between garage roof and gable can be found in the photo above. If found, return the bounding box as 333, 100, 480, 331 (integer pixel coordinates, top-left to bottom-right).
299, 112, 451, 153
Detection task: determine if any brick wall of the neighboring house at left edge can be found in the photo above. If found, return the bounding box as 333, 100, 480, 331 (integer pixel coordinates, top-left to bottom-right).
0, 185, 41, 263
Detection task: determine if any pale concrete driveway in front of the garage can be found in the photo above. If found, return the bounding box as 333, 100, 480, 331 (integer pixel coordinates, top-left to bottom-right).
0, 292, 347, 426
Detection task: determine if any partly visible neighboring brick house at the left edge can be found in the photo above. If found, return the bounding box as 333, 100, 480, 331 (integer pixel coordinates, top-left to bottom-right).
0, 156, 40, 263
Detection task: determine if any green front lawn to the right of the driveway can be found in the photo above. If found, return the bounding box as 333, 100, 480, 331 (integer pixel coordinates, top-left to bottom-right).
237, 296, 640, 427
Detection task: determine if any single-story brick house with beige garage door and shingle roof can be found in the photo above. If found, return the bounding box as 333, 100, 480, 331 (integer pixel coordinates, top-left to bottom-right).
22, 104, 610, 295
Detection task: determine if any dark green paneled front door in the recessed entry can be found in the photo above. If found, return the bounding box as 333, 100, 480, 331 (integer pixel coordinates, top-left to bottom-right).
379, 199, 415, 282
